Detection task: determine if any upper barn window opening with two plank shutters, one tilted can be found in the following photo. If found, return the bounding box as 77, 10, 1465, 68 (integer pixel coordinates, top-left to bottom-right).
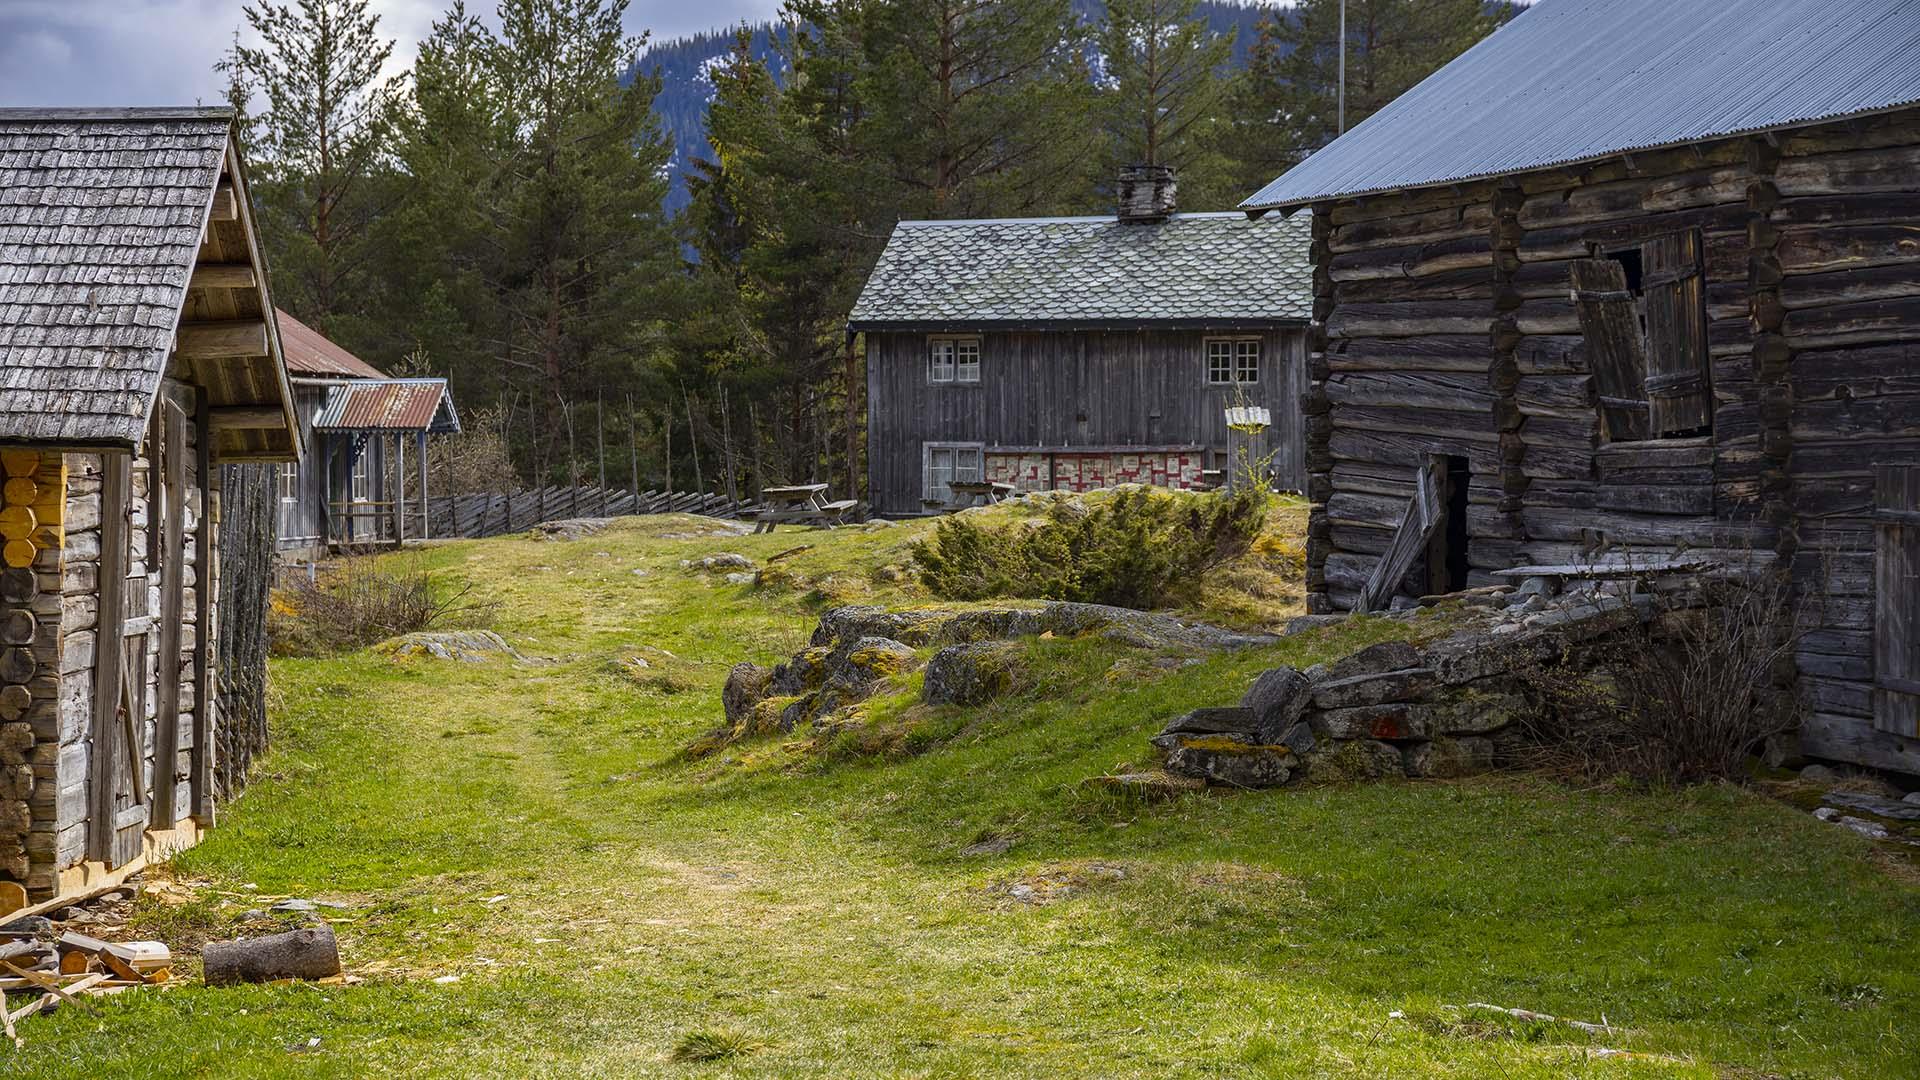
1571, 231, 1713, 442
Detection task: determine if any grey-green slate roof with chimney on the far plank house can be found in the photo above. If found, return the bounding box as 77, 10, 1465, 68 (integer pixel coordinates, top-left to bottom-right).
849, 213, 1313, 331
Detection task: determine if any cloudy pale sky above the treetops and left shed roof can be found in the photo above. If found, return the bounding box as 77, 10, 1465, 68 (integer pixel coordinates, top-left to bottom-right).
0, 0, 780, 106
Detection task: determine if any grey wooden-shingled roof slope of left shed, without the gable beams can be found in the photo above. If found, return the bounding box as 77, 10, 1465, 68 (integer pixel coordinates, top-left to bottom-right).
0, 110, 232, 446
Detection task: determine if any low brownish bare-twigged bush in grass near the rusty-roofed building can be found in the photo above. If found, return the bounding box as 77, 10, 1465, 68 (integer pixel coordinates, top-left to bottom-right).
267, 555, 493, 655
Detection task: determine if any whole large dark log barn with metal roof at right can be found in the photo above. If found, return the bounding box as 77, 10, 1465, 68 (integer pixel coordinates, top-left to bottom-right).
1242, 0, 1920, 773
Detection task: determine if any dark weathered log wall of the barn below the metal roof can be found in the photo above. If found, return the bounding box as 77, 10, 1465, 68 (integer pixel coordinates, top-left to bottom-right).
1306, 110, 1920, 773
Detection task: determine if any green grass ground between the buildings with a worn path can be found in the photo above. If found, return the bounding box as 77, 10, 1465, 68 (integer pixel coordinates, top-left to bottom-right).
15, 519, 1920, 1078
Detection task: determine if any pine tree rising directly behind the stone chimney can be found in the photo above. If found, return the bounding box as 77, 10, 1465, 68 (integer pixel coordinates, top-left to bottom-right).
1100, 0, 1233, 209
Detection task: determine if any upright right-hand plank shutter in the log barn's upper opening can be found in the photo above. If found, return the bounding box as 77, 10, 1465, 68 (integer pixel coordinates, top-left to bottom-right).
1640, 231, 1713, 438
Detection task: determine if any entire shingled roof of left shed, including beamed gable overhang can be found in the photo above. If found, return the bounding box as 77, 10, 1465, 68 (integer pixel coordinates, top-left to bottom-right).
0, 108, 298, 457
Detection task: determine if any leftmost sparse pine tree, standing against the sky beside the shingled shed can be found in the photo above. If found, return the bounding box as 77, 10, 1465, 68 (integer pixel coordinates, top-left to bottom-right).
217, 0, 394, 319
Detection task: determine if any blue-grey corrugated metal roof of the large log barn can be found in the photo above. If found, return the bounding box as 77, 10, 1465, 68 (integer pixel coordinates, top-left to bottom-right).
1240, 0, 1920, 209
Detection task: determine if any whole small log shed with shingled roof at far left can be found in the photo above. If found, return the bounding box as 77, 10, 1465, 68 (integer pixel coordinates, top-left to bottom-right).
0, 108, 300, 911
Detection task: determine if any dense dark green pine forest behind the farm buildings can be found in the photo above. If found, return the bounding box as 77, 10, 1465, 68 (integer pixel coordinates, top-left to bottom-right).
221, 0, 1511, 496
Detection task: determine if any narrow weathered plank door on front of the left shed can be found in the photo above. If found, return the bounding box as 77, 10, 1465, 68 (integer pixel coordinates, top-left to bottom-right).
86, 454, 152, 867
